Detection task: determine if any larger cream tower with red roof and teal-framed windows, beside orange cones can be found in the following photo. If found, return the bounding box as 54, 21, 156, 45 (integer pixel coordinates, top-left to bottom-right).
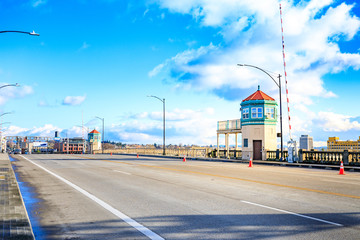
240, 86, 277, 160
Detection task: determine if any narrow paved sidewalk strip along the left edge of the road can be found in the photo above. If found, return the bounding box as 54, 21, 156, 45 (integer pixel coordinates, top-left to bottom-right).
0, 153, 34, 240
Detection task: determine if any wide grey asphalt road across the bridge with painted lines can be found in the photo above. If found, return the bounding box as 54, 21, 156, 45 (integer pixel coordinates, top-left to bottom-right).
13, 154, 360, 240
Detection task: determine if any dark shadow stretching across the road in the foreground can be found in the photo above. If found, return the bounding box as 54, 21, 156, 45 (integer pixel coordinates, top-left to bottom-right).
25, 212, 360, 240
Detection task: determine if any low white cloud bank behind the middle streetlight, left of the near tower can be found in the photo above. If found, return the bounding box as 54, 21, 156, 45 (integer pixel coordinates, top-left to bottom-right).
106, 108, 217, 145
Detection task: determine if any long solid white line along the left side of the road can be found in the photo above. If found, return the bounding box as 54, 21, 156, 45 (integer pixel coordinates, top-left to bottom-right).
22, 156, 164, 240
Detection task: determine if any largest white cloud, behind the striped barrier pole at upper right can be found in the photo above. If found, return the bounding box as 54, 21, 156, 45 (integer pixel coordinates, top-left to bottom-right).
149, 0, 360, 142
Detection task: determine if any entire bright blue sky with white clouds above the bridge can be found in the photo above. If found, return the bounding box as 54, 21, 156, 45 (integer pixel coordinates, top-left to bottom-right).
0, 0, 360, 146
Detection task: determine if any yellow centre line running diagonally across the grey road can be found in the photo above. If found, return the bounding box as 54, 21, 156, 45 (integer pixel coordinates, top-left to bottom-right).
103, 160, 360, 199
